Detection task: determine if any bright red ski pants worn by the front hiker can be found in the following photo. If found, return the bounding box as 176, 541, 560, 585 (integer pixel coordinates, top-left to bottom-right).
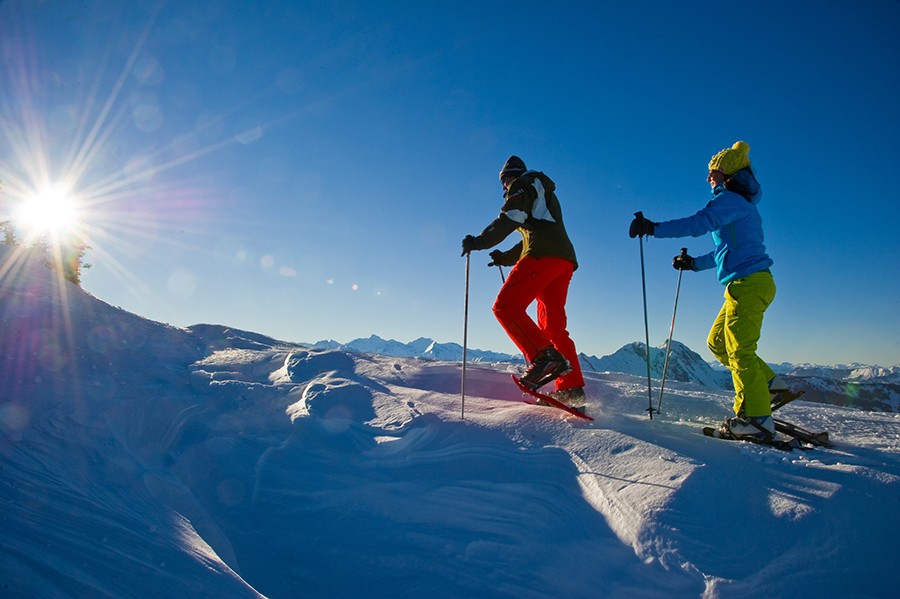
494, 257, 584, 389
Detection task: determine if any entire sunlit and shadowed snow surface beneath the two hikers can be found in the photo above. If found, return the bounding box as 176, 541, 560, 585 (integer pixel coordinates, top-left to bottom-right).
0, 246, 900, 598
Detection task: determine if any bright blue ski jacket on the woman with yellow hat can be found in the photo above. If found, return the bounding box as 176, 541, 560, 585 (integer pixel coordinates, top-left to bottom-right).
653, 169, 773, 285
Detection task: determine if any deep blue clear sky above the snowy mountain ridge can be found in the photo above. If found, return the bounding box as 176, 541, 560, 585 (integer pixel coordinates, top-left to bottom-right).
0, 0, 900, 365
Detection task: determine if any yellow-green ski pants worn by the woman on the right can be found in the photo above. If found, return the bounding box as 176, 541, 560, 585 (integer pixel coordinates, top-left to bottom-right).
707, 271, 775, 417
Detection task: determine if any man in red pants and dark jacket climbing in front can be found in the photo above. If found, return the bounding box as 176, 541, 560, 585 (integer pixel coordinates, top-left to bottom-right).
462, 156, 585, 408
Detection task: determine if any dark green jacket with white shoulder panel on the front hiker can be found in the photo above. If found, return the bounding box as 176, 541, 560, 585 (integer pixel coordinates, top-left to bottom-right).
476, 171, 578, 268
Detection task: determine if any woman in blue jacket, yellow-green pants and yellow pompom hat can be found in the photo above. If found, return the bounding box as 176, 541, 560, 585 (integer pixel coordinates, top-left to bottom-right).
629, 141, 775, 439
